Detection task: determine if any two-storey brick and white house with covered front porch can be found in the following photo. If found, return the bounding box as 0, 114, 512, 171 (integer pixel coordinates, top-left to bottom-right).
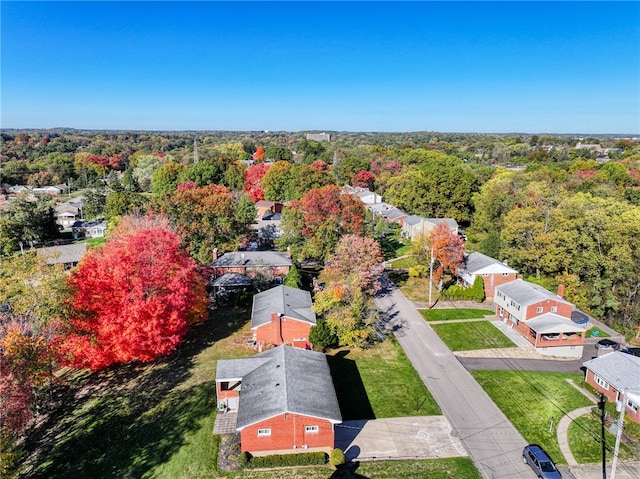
493, 279, 586, 358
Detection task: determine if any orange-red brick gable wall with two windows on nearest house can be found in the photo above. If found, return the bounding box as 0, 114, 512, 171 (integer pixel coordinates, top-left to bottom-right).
240, 413, 334, 452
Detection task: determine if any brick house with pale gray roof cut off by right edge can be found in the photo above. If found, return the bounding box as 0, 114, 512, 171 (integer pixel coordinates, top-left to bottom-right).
583, 351, 640, 423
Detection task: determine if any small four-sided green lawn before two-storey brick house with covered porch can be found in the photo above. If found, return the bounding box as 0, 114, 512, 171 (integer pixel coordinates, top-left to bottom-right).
431, 321, 515, 351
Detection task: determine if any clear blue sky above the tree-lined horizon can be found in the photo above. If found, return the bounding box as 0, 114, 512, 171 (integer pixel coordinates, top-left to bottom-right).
0, 1, 640, 134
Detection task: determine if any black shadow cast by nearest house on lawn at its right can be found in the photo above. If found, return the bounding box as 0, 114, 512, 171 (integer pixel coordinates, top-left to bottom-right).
327, 351, 375, 421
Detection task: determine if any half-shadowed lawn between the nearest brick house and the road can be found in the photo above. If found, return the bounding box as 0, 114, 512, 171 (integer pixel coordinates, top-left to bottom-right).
328, 338, 441, 420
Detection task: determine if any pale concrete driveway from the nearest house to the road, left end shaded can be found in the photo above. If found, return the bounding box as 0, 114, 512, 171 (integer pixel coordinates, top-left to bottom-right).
335, 416, 468, 461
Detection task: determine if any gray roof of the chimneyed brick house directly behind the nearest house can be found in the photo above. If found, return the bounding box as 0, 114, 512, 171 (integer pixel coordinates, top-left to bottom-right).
251, 285, 316, 329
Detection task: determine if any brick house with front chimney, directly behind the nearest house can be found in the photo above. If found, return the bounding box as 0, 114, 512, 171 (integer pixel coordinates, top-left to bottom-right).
251, 285, 316, 349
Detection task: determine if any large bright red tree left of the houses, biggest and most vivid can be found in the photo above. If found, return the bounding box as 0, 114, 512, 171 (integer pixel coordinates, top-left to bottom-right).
63, 228, 204, 370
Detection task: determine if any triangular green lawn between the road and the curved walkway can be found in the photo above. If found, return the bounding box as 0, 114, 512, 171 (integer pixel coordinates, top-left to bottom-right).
471, 371, 593, 464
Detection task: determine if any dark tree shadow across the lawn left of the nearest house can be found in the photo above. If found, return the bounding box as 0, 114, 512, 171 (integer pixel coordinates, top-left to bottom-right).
24, 310, 248, 479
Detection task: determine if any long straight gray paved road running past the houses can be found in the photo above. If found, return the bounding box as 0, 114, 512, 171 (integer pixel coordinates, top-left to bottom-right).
376, 285, 535, 479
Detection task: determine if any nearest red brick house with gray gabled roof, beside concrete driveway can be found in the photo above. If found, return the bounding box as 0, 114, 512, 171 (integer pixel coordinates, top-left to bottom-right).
216, 346, 342, 455
